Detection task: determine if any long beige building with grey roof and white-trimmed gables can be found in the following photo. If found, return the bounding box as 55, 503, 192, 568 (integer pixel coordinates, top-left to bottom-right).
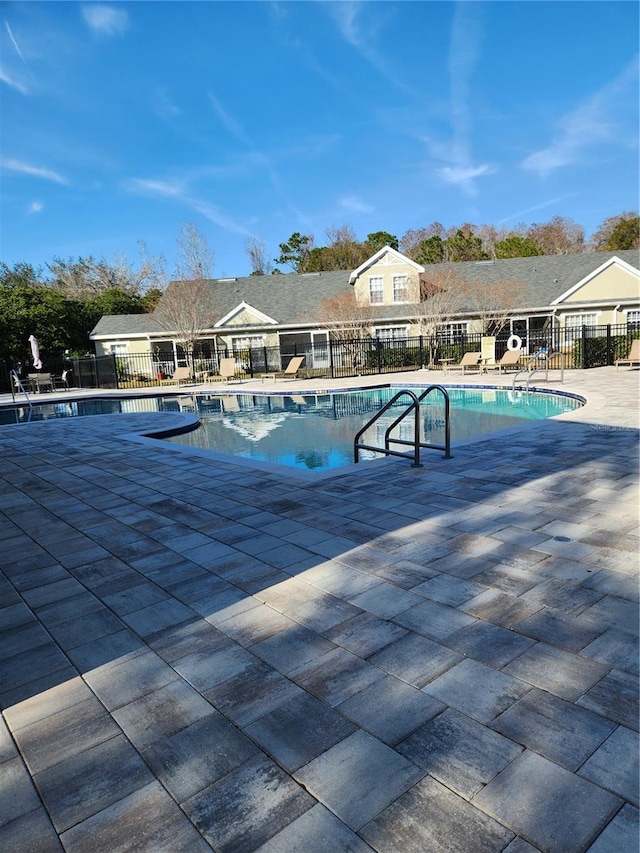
91, 246, 640, 370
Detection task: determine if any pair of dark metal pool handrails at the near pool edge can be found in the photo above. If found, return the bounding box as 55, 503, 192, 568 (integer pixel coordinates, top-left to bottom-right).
353, 385, 452, 468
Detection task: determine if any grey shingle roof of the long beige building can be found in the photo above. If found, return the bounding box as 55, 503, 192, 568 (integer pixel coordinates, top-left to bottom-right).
92, 249, 640, 337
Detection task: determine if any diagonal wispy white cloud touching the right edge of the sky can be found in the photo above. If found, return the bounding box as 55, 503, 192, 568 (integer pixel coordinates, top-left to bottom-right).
521, 58, 638, 176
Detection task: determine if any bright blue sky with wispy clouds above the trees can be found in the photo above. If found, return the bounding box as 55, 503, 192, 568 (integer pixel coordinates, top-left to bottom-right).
0, 0, 639, 276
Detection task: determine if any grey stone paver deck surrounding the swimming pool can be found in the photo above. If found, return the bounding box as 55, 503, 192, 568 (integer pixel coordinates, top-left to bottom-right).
0, 368, 640, 853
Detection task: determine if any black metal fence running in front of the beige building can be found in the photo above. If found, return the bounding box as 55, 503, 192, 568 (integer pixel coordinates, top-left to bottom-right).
0, 324, 640, 393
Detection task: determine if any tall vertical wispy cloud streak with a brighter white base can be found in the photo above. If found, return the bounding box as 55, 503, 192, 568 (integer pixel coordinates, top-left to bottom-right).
436, 2, 496, 196
